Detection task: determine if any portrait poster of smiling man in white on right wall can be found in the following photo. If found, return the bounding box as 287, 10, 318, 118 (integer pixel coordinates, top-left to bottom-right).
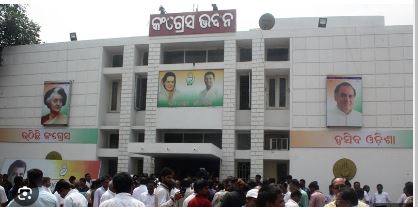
327, 76, 363, 127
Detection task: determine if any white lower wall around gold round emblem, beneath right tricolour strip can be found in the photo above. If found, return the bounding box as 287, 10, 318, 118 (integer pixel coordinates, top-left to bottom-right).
289, 148, 413, 201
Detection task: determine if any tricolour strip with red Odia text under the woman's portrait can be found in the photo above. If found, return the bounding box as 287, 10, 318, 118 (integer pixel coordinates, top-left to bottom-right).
0, 128, 97, 144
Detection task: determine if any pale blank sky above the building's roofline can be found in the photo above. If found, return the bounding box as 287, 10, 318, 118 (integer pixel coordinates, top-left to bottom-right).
14, 0, 414, 43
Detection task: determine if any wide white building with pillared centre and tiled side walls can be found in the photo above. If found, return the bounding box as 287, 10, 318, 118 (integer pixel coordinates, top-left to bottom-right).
0, 14, 413, 197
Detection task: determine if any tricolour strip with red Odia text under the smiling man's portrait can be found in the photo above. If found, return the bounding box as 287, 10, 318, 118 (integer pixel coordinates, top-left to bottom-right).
290, 130, 413, 149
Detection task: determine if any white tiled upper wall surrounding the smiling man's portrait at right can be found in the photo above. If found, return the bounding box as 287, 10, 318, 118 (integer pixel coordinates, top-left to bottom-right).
291, 26, 413, 128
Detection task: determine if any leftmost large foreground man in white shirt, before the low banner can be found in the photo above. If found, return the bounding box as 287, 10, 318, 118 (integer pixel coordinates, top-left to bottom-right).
8, 169, 59, 207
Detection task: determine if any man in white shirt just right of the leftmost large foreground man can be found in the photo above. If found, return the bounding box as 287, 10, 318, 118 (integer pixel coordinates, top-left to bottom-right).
55, 180, 88, 207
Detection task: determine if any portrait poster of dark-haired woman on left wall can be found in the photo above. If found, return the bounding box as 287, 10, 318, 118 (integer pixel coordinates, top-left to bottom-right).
41, 81, 71, 126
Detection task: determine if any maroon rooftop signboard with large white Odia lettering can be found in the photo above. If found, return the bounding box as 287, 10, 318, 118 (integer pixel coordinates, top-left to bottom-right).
149, 9, 237, 37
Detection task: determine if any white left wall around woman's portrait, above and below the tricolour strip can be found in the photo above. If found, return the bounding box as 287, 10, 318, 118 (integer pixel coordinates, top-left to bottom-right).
0, 41, 101, 166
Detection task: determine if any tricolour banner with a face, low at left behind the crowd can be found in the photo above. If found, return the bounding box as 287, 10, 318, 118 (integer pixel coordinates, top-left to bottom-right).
1, 159, 100, 183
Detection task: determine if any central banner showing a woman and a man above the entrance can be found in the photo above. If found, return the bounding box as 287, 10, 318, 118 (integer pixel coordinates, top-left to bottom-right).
157, 70, 224, 107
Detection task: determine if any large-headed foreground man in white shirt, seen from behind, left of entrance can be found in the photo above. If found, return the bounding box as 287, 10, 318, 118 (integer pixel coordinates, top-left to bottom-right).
100, 172, 145, 207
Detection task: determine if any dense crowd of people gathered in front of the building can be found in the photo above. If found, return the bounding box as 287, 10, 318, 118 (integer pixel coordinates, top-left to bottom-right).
0, 168, 413, 207
